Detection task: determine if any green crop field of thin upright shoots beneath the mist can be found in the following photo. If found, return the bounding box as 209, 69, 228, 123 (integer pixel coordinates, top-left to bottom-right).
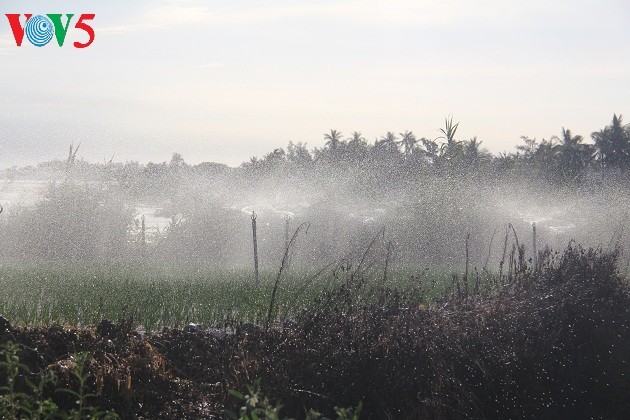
0, 262, 464, 331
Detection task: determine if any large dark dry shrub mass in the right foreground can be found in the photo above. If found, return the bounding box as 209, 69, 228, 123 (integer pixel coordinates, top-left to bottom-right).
226, 246, 630, 418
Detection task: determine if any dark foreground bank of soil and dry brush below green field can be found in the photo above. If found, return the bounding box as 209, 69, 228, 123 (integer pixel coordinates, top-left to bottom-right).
0, 247, 630, 419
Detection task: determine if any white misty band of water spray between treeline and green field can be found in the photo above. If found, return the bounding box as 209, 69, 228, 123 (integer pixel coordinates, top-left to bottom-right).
0, 169, 630, 270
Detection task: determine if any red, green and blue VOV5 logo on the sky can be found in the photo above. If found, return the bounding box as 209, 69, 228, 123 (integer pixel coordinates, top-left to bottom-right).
5, 13, 96, 48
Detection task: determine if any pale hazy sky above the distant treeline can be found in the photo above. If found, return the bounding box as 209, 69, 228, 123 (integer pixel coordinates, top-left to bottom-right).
0, 0, 630, 168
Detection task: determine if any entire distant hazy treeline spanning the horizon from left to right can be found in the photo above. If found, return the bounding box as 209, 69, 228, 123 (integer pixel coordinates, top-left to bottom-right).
6, 114, 630, 197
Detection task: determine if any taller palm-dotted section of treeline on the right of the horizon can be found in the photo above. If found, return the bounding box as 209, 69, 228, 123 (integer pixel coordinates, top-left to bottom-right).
242, 114, 630, 184
